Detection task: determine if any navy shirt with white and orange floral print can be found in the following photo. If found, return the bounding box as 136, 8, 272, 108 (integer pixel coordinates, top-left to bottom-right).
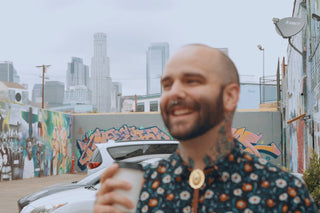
137, 142, 318, 213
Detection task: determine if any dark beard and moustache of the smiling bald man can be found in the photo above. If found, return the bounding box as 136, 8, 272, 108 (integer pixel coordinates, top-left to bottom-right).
161, 88, 224, 141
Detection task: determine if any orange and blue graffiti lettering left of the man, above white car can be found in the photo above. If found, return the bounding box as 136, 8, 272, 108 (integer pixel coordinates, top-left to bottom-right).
77, 125, 173, 170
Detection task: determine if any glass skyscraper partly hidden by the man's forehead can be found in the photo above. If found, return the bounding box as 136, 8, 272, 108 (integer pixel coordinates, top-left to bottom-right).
147, 42, 169, 95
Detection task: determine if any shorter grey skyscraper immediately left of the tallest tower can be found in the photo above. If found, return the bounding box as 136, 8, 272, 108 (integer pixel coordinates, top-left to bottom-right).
66, 57, 89, 89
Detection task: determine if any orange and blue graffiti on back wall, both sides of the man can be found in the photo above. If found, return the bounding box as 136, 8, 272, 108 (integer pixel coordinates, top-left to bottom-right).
77, 125, 281, 170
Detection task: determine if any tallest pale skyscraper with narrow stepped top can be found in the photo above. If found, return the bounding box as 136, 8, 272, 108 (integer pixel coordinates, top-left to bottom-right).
91, 33, 112, 112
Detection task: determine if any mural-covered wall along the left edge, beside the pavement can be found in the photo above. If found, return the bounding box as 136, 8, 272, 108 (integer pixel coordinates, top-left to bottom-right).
0, 102, 72, 181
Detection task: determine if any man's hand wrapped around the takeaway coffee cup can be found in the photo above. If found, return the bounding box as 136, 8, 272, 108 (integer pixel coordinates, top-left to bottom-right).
94, 164, 134, 213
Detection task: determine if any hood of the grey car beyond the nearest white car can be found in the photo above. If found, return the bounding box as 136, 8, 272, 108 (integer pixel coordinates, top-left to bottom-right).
18, 183, 87, 209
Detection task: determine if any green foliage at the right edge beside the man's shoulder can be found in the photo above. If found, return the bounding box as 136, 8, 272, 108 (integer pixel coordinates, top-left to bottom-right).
303, 152, 320, 207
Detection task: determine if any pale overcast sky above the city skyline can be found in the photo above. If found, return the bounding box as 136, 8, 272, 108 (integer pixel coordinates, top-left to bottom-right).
0, 0, 299, 95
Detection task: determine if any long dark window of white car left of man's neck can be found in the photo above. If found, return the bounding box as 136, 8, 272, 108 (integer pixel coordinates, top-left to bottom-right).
107, 144, 178, 161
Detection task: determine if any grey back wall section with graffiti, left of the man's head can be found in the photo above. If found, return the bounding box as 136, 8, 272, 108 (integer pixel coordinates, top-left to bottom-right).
73, 113, 173, 171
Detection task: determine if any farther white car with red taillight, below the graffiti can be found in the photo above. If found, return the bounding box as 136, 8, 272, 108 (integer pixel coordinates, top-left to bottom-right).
87, 140, 178, 174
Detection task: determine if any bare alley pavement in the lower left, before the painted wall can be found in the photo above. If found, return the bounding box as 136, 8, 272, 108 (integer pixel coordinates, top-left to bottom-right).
0, 173, 86, 213
